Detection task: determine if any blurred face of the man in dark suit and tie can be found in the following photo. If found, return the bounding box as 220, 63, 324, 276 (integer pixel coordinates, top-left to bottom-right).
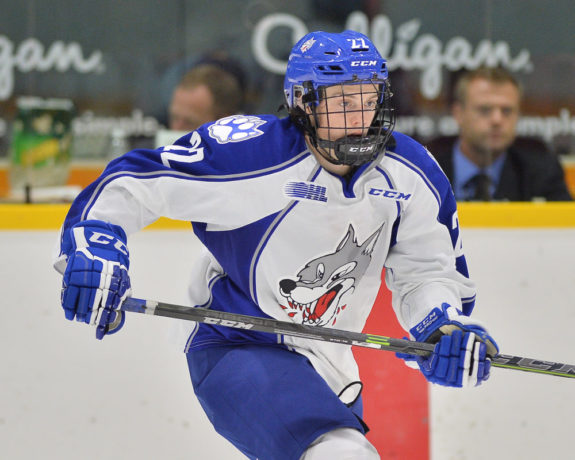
453, 78, 520, 164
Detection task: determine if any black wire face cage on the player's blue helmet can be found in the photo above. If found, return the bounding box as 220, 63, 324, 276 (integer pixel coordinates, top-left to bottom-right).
290, 80, 395, 166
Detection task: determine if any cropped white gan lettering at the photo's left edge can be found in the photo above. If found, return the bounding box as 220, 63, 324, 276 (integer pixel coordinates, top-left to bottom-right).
0, 35, 104, 101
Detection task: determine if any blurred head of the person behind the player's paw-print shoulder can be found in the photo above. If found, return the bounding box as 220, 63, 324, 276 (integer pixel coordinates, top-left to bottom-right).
168, 58, 245, 131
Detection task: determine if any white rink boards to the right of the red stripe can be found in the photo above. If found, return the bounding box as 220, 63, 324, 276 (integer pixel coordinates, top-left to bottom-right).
431, 229, 575, 460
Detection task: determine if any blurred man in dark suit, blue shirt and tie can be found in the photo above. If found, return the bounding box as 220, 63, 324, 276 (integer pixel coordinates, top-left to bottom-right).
428, 67, 572, 201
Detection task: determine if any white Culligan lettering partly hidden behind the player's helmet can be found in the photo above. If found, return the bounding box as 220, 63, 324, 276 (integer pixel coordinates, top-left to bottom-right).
252, 11, 533, 99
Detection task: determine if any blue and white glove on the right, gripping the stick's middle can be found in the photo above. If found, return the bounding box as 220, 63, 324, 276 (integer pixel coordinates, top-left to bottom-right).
397, 303, 499, 387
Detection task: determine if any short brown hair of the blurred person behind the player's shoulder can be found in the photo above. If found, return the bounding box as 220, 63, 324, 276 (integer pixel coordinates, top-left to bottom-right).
177, 64, 244, 118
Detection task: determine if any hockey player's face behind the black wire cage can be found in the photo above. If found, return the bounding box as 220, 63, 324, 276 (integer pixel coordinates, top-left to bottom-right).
316, 83, 378, 141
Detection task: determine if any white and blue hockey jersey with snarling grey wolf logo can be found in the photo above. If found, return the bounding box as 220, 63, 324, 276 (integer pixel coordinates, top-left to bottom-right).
56, 115, 475, 393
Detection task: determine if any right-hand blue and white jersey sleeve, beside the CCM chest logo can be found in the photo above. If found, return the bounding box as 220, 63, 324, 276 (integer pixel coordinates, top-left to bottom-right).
385, 134, 475, 330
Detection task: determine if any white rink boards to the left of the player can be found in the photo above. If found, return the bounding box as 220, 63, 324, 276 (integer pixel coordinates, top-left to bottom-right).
0, 232, 245, 460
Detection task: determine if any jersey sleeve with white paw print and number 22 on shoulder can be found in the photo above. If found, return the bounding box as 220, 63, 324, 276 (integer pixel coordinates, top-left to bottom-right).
56, 116, 309, 271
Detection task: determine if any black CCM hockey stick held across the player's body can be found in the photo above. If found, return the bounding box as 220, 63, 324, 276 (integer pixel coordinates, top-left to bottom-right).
121, 297, 575, 378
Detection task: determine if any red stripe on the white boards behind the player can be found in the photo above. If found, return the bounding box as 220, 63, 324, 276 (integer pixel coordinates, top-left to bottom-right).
353, 274, 430, 460
